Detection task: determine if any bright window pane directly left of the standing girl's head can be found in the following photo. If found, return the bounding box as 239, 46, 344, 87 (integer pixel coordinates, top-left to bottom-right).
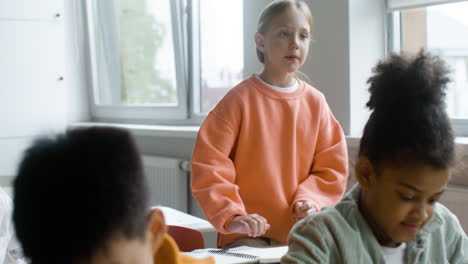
199, 0, 243, 113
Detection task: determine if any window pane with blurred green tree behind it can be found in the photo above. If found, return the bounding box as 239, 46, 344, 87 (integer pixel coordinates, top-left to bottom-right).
116, 0, 178, 105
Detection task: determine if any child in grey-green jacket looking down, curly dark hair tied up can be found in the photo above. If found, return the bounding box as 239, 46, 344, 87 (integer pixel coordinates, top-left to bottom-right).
281, 52, 468, 264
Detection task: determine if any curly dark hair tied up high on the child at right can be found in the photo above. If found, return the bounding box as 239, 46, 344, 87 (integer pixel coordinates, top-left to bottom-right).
359, 51, 454, 169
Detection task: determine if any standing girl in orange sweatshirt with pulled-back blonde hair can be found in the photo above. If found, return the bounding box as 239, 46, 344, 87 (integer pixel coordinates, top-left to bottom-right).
192, 0, 348, 247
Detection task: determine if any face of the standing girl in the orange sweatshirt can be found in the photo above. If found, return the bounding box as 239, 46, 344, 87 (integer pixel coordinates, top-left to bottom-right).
255, 7, 311, 74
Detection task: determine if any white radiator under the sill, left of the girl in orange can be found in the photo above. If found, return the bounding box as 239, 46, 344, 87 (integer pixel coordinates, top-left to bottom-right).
142, 155, 190, 213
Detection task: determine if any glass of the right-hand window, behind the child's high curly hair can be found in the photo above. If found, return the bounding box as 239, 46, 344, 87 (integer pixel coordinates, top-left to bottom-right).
394, 2, 468, 119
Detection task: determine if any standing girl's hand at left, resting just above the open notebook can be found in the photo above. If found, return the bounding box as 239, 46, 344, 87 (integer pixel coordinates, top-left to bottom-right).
227, 214, 270, 237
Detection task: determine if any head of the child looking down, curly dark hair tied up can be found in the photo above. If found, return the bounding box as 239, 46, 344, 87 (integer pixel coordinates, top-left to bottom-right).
356, 52, 454, 246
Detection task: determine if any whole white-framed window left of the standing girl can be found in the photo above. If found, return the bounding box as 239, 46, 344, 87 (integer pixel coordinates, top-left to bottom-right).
87, 0, 243, 124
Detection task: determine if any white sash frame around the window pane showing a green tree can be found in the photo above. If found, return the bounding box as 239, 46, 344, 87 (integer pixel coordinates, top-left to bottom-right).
86, 0, 190, 124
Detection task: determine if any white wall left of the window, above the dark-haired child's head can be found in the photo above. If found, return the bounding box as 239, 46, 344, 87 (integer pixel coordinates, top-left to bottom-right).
0, 0, 89, 179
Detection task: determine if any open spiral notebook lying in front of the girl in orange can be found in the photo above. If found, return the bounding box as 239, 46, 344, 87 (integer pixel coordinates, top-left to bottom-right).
187, 246, 288, 264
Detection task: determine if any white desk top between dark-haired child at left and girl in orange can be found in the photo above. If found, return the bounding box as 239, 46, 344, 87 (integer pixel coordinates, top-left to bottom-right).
153, 206, 216, 233
